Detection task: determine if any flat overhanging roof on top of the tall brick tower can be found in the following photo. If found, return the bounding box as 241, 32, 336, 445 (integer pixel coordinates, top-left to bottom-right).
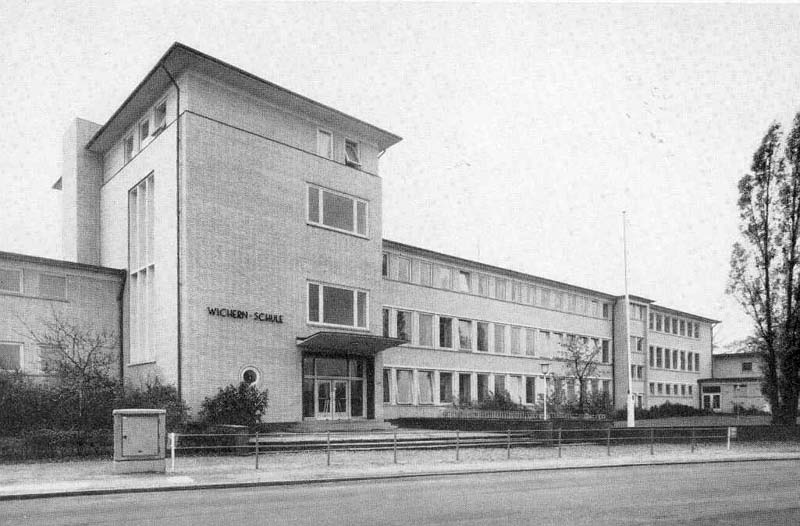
86, 42, 402, 152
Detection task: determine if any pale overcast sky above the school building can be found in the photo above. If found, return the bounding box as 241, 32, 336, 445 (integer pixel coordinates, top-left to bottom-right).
0, 1, 800, 343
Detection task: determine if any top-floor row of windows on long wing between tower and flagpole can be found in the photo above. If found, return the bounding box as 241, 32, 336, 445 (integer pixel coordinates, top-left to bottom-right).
382, 253, 611, 318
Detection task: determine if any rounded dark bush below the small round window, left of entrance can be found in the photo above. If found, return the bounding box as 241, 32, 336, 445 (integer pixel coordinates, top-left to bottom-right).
199, 382, 269, 427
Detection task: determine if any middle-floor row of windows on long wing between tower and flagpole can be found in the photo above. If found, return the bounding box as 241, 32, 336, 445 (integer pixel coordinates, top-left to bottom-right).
383, 308, 611, 363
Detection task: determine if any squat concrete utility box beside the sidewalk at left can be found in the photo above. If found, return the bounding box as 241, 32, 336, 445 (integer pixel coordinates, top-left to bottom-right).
114, 409, 167, 473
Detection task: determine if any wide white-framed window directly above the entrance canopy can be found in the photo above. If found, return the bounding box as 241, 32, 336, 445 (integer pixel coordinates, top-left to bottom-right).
308, 283, 367, 329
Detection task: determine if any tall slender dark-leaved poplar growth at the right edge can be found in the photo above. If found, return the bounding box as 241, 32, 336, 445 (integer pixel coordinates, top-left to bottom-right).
728, 113, 800, 424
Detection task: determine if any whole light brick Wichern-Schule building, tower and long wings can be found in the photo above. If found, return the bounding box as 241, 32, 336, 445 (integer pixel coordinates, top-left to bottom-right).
0, 43, 717, 422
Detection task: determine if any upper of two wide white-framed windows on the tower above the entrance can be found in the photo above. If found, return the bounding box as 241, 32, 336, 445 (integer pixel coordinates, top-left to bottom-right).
308, 186, 367, 236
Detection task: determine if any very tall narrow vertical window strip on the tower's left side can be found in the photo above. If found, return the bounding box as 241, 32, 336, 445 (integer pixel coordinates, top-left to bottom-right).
128, 174, 155, 363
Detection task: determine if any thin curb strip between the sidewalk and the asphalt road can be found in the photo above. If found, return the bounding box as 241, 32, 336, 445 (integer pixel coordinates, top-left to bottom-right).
0, 454, 800, 502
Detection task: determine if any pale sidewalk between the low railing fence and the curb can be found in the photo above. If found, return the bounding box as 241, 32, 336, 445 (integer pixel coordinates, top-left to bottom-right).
0, 443, 800, 500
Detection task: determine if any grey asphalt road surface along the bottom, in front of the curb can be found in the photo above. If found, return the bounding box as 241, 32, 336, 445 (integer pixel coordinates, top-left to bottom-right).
0, 461, 800, 526
